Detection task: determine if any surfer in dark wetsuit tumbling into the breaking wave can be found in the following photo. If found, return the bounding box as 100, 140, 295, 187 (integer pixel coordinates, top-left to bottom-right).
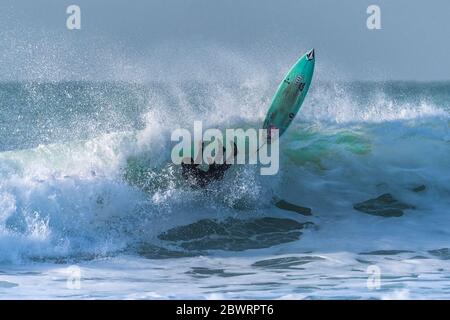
181, 144, 237, 188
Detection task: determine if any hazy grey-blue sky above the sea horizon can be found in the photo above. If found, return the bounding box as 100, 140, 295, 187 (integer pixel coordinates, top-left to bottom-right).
0, 0, 450, 81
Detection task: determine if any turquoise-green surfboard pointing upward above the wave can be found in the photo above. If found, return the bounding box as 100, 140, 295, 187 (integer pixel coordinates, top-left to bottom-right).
263, 49, 315, 143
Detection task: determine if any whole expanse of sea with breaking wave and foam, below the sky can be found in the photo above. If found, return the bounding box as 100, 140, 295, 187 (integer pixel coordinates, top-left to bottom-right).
0, 80, 450, 299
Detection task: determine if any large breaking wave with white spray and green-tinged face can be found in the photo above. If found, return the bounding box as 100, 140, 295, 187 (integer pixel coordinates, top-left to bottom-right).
0, 82, 450, 262
